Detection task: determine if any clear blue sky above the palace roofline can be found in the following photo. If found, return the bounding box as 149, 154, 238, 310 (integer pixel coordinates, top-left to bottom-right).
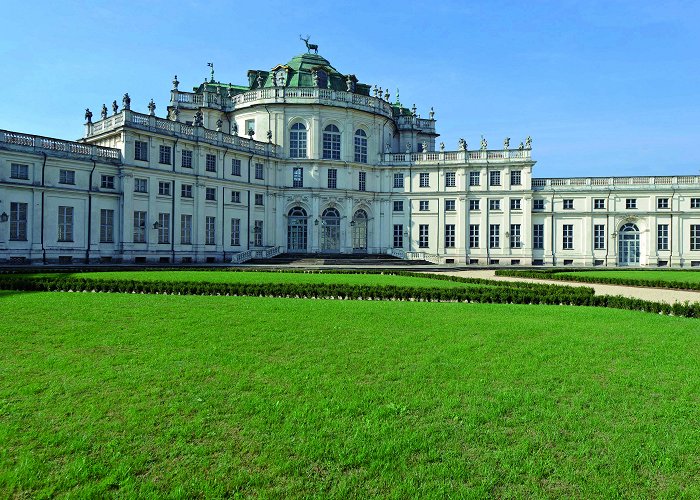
0, 0, 700, 177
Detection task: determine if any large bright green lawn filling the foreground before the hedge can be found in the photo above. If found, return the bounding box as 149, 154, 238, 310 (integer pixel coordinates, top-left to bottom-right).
0, 292, 700, 498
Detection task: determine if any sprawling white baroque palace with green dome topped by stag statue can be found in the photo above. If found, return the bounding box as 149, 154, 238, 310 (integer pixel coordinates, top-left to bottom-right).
0, 45, 700, 267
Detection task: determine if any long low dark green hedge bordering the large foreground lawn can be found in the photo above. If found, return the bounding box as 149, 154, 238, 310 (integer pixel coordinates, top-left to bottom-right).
0, 276, 700, 318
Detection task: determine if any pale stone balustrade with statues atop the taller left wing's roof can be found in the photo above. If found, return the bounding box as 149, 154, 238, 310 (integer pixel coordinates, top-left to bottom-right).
87, 109, 277, 156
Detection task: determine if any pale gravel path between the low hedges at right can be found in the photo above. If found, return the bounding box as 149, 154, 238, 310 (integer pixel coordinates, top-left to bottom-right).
433, 269, 700, 304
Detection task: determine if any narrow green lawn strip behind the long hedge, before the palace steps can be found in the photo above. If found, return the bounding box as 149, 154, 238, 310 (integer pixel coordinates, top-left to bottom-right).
15, 271, 476, 288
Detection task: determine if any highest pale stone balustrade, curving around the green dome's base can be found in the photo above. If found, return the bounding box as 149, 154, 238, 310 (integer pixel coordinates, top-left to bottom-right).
170, 87, 404, 122
